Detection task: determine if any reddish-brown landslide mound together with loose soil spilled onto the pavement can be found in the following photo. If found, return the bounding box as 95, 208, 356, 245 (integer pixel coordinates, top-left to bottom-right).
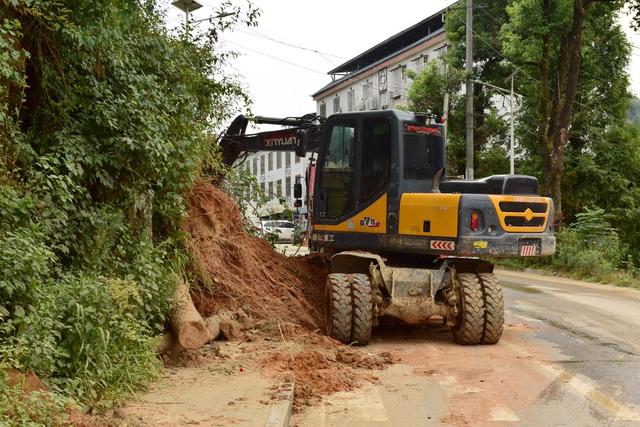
176, 183, 393, 410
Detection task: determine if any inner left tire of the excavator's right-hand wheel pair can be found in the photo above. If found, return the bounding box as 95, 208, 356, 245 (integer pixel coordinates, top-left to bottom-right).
453, 273, 485, 345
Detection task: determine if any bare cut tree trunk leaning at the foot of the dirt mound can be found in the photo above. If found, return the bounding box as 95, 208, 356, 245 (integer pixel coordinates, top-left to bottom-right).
171, 279, 211, 349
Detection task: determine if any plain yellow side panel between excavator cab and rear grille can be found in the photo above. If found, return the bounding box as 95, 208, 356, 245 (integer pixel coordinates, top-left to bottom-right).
398, 193, 460, 237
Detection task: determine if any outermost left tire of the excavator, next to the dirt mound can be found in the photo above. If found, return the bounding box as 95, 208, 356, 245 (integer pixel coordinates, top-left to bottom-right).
325, 273, 352, 343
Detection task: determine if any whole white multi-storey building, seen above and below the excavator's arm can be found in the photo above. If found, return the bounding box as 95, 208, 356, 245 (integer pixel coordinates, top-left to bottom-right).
246, 5, 447, 216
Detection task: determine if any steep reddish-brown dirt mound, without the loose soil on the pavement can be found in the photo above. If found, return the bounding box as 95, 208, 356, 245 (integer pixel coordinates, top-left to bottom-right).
184, 183, 327, 330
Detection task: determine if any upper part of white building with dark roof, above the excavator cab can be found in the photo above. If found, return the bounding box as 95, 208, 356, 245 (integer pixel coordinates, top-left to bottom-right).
312, 10, 447, 117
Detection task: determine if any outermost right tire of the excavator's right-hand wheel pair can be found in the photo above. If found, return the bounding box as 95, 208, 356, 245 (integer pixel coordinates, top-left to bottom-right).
478, 273, 504, 344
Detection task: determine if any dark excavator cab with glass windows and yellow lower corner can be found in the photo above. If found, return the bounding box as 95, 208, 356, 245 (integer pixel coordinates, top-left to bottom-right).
313, 110, 445, 236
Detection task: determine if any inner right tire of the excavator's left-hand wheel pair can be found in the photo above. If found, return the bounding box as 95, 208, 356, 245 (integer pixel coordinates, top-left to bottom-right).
351, 274, 373, 345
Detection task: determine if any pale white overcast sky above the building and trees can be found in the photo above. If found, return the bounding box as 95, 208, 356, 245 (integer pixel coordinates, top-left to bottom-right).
164, 0, 640, 123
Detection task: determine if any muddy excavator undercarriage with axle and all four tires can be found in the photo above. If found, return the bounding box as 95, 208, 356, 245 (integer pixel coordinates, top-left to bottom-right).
325, 251, 504, 345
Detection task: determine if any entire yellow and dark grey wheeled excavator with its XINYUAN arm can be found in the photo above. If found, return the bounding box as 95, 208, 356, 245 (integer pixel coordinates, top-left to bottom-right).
220, 110, 555, 345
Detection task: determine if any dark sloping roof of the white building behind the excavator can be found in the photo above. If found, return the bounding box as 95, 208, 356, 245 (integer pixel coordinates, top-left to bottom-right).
311, 9, 446, 97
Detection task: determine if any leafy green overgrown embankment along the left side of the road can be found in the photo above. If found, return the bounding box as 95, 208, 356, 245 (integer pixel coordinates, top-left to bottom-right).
0, 0, 256, 424
